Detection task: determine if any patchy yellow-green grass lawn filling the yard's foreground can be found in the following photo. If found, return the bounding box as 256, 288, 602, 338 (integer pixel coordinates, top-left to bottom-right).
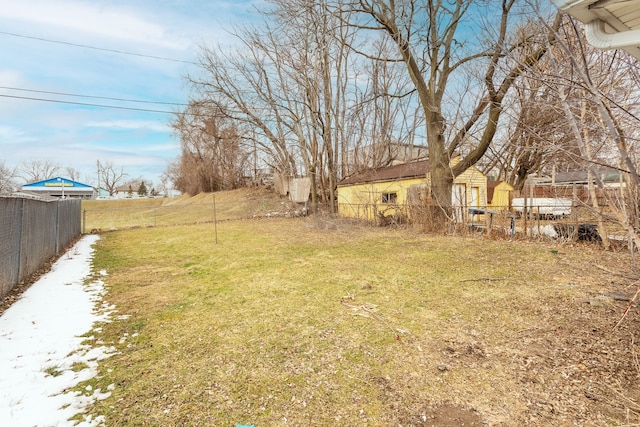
83, 218, 640, 426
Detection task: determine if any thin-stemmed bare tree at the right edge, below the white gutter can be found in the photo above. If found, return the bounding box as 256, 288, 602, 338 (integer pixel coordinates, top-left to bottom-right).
545, 14, 640, 258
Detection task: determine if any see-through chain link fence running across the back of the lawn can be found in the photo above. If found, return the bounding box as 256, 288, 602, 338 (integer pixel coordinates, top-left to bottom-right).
82, 196, 625, 244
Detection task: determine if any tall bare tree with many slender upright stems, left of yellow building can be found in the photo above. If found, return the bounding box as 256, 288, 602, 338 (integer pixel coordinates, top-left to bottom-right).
189, 0, 413, 210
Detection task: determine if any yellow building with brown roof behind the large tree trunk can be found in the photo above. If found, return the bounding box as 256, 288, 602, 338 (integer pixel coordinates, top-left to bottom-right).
338, 159, 487, 220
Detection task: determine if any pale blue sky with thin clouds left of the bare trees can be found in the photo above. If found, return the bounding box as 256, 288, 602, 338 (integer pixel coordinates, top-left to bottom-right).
0, 0, 256, 184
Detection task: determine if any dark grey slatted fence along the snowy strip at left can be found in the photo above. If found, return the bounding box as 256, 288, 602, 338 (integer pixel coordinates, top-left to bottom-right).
0, 197, 81, 299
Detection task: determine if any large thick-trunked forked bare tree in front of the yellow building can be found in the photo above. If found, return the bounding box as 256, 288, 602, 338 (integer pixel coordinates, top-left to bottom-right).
340, 0, 552, 226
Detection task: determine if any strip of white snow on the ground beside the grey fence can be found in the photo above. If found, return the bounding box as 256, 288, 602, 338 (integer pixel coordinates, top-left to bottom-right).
0, 235, 115, 427
